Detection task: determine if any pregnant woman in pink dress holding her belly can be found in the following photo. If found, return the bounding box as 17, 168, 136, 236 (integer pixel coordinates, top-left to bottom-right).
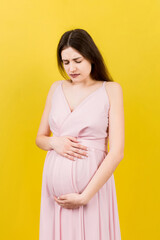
36, 29, 124, 240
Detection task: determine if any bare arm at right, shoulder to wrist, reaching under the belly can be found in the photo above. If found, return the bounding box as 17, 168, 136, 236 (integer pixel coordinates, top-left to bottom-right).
81, 82, 124, 204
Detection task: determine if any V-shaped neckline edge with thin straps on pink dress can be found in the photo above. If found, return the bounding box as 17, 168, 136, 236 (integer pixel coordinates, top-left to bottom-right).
60, 80, 105, 114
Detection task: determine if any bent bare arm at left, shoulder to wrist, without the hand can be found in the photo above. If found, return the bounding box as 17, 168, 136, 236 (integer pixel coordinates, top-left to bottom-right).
35, 81, 59, 151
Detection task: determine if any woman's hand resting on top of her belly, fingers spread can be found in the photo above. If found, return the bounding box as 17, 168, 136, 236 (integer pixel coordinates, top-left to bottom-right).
51, 136, 88, 161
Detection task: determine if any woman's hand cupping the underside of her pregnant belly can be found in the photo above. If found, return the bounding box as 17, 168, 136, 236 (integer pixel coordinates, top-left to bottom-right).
54, 193, 86, 209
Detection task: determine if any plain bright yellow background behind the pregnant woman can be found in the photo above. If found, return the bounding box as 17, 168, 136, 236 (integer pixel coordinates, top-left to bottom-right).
0, 0, 160, 240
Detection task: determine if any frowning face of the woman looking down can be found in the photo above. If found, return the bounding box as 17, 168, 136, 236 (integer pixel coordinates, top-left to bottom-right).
61, 47, 92, 82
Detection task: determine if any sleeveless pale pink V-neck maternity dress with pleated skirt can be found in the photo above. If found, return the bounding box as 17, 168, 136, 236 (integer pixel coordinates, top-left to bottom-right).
39, 80, 121, 240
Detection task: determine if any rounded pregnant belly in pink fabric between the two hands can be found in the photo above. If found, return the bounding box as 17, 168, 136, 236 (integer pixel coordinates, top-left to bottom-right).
46, 149, 106, 197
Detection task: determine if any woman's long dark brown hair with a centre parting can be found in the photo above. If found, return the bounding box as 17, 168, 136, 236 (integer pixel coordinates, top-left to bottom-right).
57, 29, 113, 81
